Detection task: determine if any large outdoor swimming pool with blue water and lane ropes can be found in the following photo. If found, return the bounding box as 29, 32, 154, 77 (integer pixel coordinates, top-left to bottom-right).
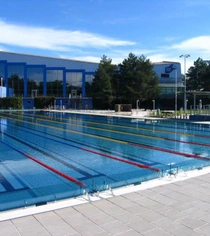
0, 111, 210, 211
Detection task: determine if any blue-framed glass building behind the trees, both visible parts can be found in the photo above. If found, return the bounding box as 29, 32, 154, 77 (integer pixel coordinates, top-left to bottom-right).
0, 51, 183, 98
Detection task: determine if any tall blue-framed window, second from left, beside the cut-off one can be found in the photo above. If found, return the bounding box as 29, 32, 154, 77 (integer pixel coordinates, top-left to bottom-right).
7, 64, 25, 97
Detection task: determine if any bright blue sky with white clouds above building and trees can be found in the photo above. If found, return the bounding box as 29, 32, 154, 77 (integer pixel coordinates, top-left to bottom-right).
0, 0, 210, 73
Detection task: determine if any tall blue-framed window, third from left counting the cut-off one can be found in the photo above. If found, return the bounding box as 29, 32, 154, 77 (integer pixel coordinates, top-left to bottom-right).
27, 67, 44, 97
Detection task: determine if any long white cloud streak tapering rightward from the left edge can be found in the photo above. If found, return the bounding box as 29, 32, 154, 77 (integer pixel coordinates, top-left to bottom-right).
0, 20, 135, 51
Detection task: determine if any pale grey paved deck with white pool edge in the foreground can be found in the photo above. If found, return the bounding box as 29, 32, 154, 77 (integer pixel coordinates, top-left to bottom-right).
0, 109, 210, 236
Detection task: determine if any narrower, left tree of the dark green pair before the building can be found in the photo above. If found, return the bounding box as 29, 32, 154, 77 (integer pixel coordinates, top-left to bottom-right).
88, 55, 116, 108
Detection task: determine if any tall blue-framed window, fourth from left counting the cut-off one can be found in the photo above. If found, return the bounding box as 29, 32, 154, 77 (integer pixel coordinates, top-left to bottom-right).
46, 69, 63, 97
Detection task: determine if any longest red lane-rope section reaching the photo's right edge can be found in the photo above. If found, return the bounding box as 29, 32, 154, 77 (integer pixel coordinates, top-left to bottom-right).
128, 143, 210, 161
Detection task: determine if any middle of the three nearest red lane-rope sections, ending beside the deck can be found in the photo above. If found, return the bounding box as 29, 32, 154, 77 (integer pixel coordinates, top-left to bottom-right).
82, 148, 160, 172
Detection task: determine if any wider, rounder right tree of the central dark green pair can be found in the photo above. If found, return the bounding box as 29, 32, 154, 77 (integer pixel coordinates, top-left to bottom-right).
119, 53, 161, 103
